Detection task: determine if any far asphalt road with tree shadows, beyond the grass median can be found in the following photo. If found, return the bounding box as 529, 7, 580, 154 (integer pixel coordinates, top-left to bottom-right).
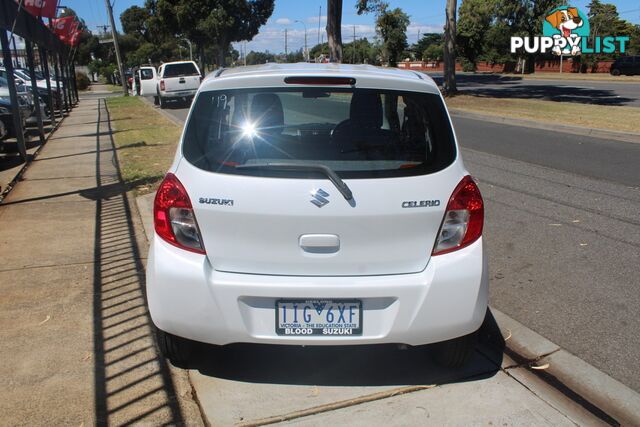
429, 73, 640, 107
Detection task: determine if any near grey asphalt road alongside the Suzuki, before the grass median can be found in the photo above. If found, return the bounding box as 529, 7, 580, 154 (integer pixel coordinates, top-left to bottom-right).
158, 98, 640, 391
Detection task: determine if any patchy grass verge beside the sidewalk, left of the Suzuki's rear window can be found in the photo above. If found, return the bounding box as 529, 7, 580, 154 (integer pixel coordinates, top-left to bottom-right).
107, 96, 181, 194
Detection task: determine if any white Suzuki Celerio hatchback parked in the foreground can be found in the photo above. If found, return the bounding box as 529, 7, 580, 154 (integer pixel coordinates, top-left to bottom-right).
147, 64, 488, 366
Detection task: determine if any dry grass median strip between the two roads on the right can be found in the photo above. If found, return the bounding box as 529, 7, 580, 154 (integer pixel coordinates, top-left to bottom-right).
446, 95, 640, 133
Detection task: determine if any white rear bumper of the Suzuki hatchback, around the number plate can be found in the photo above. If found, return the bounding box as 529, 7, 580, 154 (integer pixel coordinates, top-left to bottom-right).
147, 236, 489, 345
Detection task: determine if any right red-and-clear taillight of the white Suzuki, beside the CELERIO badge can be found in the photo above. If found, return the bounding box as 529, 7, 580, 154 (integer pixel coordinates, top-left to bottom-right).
431, 175, 484, 255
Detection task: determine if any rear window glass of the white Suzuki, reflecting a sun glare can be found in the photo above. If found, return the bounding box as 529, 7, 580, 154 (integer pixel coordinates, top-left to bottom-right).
183, 88, 456, 178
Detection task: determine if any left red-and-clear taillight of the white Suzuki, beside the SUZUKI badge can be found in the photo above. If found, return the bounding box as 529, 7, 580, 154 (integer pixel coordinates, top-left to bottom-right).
153, 173, 205, 254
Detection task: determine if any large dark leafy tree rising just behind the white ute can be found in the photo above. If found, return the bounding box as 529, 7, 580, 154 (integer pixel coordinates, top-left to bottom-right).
155, 0, 274, 70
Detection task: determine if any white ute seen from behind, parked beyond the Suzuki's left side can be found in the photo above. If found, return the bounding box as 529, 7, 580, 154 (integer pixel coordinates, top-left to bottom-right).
155, 61, 202, 108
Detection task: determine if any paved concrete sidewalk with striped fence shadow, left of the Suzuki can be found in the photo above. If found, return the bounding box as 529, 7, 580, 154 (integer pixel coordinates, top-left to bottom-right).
0, 98, 202, 426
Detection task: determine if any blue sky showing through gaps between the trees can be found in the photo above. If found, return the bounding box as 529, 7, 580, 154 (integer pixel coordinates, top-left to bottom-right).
66, 0, 640, 53
